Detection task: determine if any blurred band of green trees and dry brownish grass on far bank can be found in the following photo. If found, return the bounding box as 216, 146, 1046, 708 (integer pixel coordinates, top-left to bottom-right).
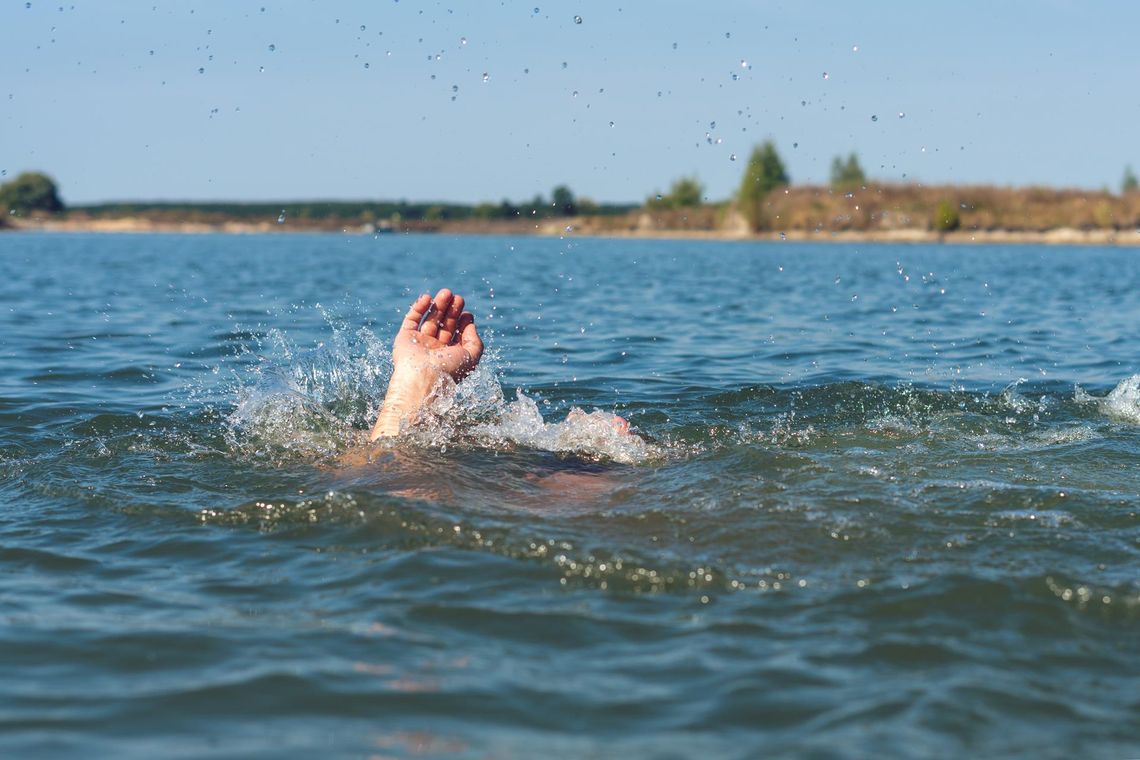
0, 141, 1140, 235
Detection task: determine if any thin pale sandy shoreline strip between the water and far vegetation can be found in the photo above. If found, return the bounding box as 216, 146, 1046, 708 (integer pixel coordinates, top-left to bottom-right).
7, 216, 1140, 246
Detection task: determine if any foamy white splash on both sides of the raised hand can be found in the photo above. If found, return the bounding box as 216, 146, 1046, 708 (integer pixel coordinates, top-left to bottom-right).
226, 307, 660, 464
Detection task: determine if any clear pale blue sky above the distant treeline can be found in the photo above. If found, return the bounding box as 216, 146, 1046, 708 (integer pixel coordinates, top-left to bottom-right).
0, 0, 1140, 204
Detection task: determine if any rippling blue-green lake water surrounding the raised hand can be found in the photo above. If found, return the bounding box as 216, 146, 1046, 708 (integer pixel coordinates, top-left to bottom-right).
0, 234, 1140, 758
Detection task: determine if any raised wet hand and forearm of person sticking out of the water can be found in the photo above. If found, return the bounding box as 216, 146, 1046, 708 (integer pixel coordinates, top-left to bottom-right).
372, 287, 483, 441
